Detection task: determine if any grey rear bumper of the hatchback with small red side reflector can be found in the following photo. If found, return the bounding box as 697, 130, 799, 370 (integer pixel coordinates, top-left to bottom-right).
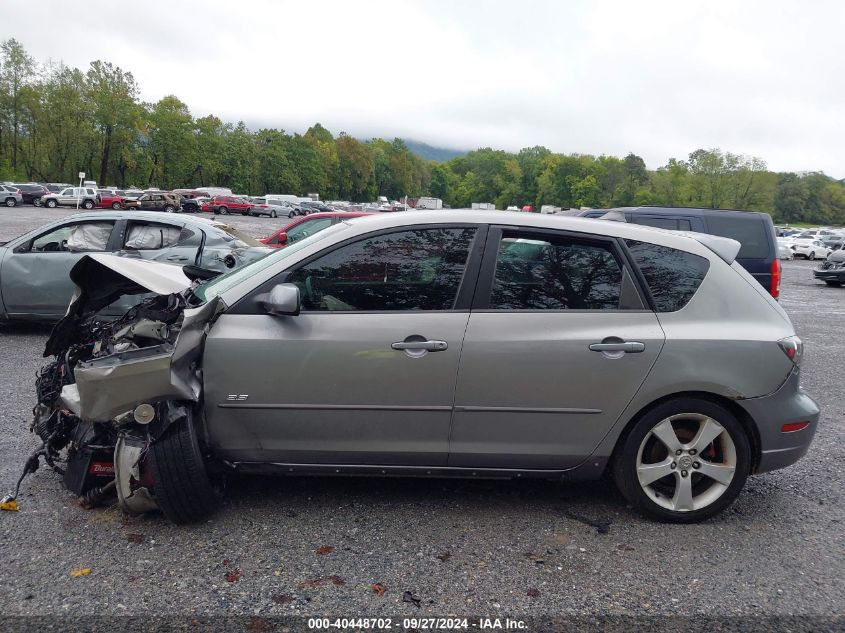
737, 370, 820, 474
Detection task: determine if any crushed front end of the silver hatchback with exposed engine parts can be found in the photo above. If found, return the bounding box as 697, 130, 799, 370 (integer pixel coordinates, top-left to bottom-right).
4, 254, 220, 513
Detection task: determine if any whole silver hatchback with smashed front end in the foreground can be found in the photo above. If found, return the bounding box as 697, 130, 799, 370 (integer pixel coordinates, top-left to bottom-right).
21, 210, 819, 523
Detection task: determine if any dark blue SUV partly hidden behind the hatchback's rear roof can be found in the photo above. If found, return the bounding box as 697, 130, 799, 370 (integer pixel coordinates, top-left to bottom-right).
579, 207, 781, 297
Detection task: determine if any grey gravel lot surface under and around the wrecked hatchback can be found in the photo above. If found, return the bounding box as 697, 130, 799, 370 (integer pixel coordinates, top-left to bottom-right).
0, 207, 845, 617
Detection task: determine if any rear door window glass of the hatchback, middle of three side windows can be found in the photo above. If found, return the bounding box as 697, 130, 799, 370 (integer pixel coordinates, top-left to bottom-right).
490, 233, 623, 310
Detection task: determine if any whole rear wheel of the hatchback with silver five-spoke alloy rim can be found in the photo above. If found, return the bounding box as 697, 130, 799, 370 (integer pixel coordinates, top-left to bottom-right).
613, 398, 751, 523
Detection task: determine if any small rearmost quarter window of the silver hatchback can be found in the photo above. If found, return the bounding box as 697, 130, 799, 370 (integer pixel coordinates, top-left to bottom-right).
625, 240, 710, 312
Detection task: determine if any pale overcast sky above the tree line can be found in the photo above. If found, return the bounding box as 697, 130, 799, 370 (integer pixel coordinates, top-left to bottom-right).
6, 0, 845, 178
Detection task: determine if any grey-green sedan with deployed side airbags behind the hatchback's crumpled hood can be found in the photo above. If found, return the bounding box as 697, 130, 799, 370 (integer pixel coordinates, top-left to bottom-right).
0, 211, 270, 321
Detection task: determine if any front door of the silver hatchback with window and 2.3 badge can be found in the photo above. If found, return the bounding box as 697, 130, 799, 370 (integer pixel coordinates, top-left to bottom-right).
203, 226, 478, 465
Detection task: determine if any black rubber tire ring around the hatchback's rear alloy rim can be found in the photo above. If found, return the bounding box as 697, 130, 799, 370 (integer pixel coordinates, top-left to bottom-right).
613, 398, 751, 523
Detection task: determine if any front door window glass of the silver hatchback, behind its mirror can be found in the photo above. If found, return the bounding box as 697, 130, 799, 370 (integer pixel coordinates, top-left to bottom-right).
288, 228, 476, 312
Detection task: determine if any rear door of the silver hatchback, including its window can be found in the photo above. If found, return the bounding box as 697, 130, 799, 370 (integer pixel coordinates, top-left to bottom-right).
449, 228, 664, 470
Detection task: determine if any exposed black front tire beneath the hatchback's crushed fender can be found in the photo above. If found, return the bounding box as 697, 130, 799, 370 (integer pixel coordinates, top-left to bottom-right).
150, 408, 220, 524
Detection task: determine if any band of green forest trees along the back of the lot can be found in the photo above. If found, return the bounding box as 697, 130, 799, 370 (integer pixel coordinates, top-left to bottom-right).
0, 39, 845, 224
